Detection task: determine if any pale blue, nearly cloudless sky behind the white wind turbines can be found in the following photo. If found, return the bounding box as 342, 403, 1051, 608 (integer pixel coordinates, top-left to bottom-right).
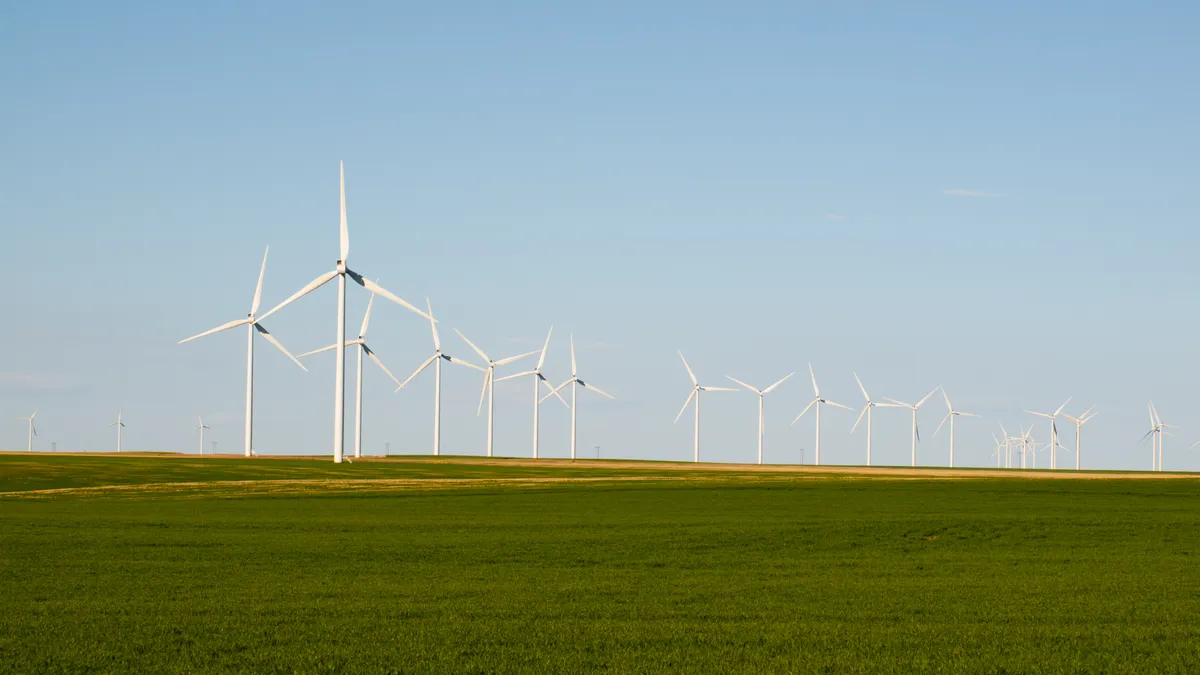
0, 1, 1200, 470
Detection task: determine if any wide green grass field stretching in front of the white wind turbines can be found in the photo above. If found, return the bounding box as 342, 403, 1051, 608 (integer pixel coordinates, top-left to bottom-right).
0, 455, 1200, 673
